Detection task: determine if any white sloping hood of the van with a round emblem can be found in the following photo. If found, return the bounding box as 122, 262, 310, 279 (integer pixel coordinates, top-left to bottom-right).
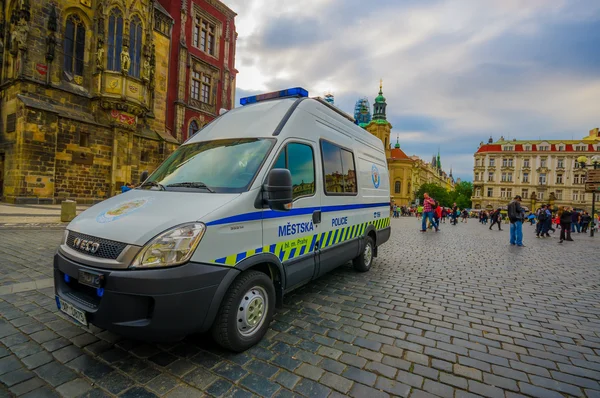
67, 189, 239, 246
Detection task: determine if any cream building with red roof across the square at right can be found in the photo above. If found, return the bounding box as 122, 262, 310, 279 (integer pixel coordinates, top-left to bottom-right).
472, 128, 600, 211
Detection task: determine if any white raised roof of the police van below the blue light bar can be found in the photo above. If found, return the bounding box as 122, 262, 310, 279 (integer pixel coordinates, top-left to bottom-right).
184, 98, 381, 151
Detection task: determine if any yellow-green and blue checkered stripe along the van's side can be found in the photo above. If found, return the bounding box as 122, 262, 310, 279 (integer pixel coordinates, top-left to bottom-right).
213, 217, 390, 267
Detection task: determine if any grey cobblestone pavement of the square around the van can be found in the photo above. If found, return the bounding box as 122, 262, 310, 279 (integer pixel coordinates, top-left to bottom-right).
0, 219, 600, 398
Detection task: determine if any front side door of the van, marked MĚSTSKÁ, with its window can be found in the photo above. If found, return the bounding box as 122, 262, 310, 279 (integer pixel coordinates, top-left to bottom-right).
263, 139, 321, 290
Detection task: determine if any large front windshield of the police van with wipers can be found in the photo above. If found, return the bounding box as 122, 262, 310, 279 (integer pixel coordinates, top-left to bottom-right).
142, 138, 274, 193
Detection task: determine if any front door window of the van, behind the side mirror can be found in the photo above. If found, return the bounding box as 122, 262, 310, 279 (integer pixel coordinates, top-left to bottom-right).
273, 143, 315, 200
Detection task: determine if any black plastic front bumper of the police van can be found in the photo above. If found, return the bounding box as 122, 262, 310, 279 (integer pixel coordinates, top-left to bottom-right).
54, 253, 239, 341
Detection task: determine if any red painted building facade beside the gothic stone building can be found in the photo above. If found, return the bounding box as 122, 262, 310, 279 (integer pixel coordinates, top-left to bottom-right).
159, 0, 237, 142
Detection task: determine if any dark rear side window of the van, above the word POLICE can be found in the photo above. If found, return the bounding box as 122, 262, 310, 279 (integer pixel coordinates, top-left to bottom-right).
321, 141, 357, 195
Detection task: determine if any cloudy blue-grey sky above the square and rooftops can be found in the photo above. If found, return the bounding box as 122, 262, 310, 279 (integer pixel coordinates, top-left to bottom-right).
224, 0, 600, 180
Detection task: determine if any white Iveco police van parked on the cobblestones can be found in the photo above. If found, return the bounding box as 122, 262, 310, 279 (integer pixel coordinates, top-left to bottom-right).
54, 88, 390, 351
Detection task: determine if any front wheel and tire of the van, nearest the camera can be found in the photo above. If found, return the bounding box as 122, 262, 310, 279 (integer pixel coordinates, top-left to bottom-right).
212, 270, 275, 352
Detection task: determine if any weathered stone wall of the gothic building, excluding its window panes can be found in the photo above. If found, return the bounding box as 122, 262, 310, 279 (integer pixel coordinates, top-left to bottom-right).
0, 0, 177, 203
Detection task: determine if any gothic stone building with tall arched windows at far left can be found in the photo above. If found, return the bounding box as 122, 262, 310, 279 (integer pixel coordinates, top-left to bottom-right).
0, 0, 178, 203
